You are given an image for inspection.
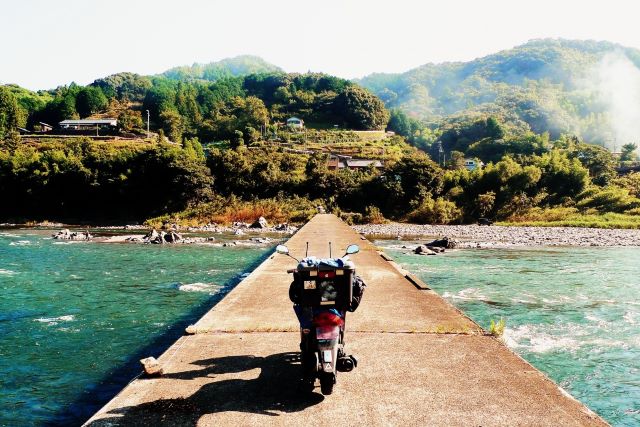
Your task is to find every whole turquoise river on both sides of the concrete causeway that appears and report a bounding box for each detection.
[0,229,640,426]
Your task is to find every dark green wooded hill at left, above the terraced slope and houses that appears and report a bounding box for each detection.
[0,70,389,144]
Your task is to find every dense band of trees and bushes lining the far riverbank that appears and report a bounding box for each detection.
[0,130,640,224]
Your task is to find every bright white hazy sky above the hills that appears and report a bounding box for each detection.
[0,0,640,89]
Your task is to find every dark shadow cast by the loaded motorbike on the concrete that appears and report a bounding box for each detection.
[89,353,324,427]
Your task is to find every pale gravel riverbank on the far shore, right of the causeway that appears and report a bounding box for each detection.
[353,223,640,248]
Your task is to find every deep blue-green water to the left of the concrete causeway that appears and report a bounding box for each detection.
[0,230,270,426]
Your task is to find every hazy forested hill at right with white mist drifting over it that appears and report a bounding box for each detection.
[358,39,640,148]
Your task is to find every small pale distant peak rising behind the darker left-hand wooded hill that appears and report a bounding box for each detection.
[161,55,284,81]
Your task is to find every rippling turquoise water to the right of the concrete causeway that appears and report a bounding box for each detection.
[376,241,640,426]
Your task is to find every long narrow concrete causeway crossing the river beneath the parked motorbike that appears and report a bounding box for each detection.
[85,214,607,427]
